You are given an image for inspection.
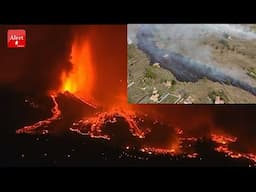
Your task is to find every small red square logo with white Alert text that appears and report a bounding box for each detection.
[7,29,26,48]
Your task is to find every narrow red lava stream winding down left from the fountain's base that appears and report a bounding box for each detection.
[16,95,61,134]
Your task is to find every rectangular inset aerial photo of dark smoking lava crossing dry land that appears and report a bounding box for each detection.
[127,24,256,104]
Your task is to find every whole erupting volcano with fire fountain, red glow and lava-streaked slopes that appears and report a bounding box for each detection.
[1,25,256,165]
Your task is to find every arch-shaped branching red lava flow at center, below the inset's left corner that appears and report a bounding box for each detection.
[70,109,145,140]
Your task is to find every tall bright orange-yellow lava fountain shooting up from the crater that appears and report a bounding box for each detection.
[61,39,94,101]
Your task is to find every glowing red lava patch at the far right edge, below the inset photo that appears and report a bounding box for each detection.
[212,134,256,162]
